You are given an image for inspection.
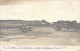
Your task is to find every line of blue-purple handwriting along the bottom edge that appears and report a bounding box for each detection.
[3,46,67,50]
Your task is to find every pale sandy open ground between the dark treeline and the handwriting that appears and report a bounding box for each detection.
[0,27,80,46]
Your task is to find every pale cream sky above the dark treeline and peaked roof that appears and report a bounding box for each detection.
[0,0,80,22]
